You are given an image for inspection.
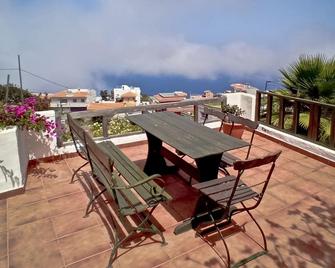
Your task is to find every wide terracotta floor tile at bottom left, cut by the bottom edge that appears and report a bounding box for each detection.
[9,241,63,268]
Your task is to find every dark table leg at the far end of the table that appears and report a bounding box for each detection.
[144,132,177,175]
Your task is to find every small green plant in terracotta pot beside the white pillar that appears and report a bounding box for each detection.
[221,104,244,139]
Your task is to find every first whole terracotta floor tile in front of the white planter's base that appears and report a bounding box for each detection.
[7,187,46,209]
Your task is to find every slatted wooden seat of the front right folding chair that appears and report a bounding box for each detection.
[193,176,259,207]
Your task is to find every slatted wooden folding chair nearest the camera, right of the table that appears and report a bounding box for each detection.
[192,151,281,265]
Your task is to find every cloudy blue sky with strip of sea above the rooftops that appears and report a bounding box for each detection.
[0,0,335,93]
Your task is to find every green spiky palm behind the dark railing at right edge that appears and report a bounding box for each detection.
[279,55,335,100]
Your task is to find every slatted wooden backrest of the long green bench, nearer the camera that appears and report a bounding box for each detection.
[84,132,114,186]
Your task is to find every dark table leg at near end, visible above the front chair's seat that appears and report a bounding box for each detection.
[195,153,222,182]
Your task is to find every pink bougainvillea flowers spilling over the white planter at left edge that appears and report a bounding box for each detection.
[0,97,56,137]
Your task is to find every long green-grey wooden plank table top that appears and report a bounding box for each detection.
[127,112,249,159]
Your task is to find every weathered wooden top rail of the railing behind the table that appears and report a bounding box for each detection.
[71,96,227,119]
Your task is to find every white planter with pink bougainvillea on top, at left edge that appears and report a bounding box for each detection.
[0,97,56,194]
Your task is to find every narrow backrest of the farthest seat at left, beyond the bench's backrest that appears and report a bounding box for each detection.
[67,113,87,160]
